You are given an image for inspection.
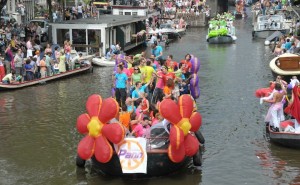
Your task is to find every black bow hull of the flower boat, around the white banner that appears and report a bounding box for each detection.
[92,152,192,179]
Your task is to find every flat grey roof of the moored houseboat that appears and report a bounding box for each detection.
[51,14,147,26]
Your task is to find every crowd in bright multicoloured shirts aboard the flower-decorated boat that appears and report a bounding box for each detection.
[112,43,196,137]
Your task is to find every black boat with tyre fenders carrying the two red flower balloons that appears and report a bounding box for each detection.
[76,121,204,179]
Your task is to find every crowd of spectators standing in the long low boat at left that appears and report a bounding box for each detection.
[0,40,83,84]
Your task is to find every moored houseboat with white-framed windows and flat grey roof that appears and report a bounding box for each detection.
[51,6,147,56]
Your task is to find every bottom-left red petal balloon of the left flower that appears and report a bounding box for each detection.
[77,135,95,160]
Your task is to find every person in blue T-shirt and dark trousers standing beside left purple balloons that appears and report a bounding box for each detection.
[113,65,128,107]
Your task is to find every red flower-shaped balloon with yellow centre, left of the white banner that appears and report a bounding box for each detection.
[77,94,125,163]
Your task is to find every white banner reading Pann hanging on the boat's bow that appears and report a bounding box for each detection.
[114,137,147,173]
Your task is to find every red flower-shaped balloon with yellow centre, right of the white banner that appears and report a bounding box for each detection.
[159,95,202,162]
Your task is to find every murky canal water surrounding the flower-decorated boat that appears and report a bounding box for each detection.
[0,8,300,185]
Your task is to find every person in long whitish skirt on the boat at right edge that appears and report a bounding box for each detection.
[264,83,286,132]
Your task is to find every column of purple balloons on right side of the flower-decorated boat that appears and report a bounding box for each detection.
[190,55,200,100]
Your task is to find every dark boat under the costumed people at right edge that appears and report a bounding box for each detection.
[266,120,300,149]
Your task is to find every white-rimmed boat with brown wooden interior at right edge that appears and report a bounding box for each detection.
[269,53,300,80]
